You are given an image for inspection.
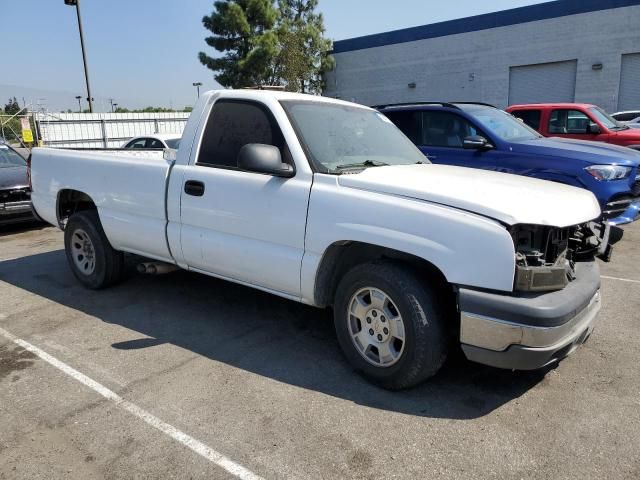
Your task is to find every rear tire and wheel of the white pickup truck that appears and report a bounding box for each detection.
[64,211,124,290]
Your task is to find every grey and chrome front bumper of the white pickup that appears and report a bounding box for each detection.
[458,262,601,370]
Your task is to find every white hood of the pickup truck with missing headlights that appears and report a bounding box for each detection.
[338,164,600,227]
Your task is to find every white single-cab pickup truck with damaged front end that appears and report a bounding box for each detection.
[31,90,608,389]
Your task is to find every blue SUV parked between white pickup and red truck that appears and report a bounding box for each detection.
[379,103,640,225]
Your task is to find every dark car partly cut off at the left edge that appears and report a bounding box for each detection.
[0,143,34,225]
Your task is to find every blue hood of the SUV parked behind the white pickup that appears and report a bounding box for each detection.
[511,138,640,167]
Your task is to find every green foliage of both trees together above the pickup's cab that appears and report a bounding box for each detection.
[199,0,333,93]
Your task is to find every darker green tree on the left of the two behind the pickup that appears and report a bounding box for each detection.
[198,0,278,88]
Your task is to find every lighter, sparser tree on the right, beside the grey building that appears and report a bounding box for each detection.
[272,0,334,94]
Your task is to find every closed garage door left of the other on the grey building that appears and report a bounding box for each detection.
[509,60,578,105]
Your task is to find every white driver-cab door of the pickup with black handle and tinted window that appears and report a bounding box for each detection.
[180,99,312,297]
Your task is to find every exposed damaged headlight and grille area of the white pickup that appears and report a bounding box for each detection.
[510,222,612,292]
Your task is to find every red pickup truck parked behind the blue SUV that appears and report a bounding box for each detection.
[507,103,640,150]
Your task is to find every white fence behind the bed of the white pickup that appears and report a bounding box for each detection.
[34,112,189,148]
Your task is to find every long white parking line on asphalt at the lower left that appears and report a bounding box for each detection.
[0,328,262,480]
